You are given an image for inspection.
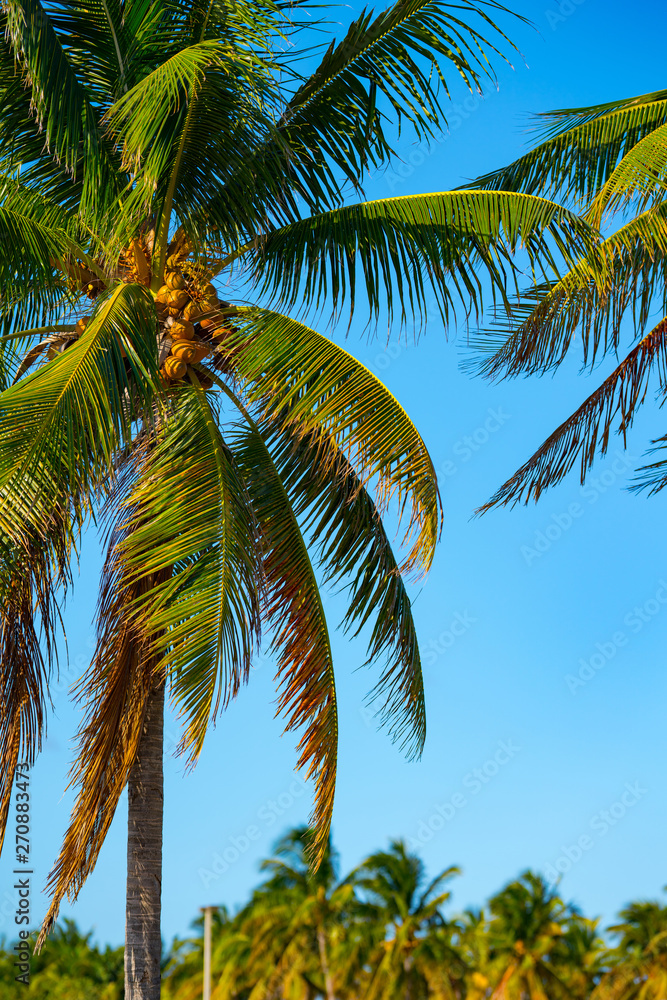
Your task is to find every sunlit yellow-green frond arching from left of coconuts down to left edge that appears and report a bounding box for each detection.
[0,285,161,537]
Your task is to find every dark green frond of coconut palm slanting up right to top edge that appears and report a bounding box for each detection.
[213,0,514,227]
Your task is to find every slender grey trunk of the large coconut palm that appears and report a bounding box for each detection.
[125,680,164,1000]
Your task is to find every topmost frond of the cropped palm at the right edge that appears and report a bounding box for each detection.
[475,90,667,205]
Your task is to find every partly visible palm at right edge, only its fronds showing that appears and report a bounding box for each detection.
[464,91,667,510]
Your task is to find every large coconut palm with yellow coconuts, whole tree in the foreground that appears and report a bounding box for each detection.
[0,0,589,1000]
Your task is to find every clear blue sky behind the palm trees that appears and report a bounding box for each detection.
[0,0,667,943]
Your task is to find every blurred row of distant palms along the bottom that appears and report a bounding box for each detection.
[0,829,667,1000]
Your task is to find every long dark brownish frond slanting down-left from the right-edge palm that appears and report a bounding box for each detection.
[478,318,667,513]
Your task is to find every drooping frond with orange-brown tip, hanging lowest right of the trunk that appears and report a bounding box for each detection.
[234,425,338,862]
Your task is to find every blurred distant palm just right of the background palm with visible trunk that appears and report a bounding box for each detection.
[351,840,464,1000]
